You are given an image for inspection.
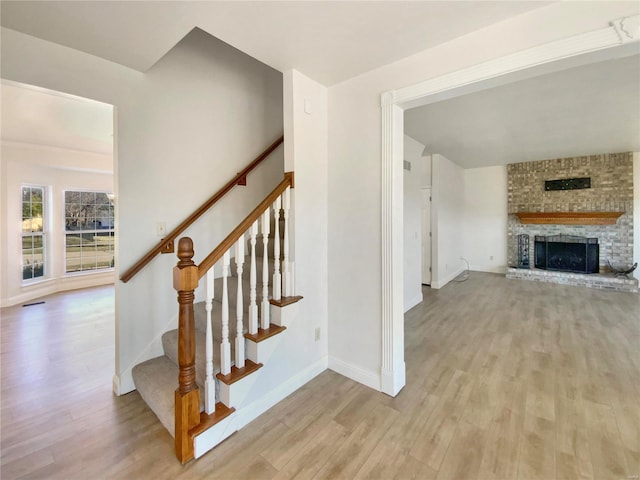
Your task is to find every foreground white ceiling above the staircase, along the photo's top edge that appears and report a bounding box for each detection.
[0,0,552,86]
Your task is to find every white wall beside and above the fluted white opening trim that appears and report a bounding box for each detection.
[329,2,636,384]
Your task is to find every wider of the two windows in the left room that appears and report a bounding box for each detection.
[64,190,115,273]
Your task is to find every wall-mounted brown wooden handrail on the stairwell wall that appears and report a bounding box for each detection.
[120,136,284,283]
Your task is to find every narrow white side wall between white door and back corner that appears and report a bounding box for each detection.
[431,154,465,289]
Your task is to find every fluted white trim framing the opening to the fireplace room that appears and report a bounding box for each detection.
[380,15,640,396]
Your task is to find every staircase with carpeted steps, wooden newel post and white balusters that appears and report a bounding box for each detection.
[132,172,302,463]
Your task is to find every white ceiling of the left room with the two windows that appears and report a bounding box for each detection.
[0,81,113,155]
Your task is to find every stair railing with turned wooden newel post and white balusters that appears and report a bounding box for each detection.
[173,172,294,463]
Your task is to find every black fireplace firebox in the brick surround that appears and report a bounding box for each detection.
[534,235,600,273]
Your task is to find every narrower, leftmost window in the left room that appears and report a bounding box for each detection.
[22,186,45,282]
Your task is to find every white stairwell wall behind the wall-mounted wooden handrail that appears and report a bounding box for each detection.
[2,29,283,393]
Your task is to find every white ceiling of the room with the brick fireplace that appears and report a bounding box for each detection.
[405,55,640,168]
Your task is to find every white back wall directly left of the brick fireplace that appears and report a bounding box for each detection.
[463,166,507,273]
